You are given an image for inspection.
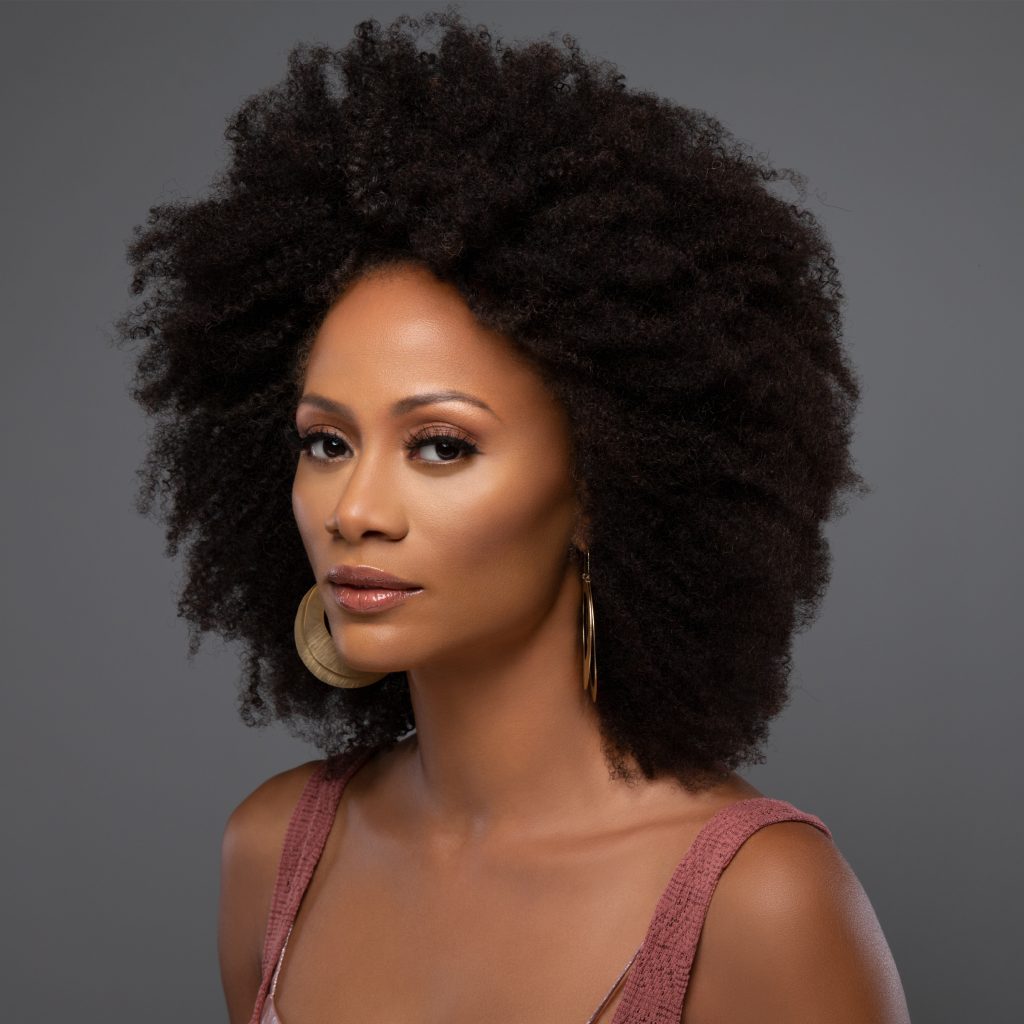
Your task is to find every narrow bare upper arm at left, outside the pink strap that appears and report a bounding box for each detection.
[217,761,319,1024]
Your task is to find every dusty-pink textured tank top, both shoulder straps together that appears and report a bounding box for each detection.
[249,748,833,1024]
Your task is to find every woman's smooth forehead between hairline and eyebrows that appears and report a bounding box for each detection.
[305,267,553,416]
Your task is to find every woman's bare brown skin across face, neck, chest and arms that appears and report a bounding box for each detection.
[219,267,908,1024]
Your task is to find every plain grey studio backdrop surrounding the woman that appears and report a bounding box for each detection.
[0,2,1024,1024]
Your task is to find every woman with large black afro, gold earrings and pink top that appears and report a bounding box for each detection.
[114,8,908,1024]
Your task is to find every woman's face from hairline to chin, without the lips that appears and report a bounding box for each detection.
[292,266,584,672]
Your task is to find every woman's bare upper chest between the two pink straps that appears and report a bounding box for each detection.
[275,823,700,1024]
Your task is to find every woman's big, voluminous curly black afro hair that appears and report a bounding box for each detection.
[114,4,870,791]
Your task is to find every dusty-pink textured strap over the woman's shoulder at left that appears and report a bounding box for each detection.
[249,748,377,1024]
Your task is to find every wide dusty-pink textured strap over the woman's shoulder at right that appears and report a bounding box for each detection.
[611,797,833,1024]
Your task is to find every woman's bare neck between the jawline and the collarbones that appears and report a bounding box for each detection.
[395,567,649,846]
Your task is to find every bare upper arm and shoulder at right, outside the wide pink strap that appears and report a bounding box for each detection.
[683,821,910,1024]
